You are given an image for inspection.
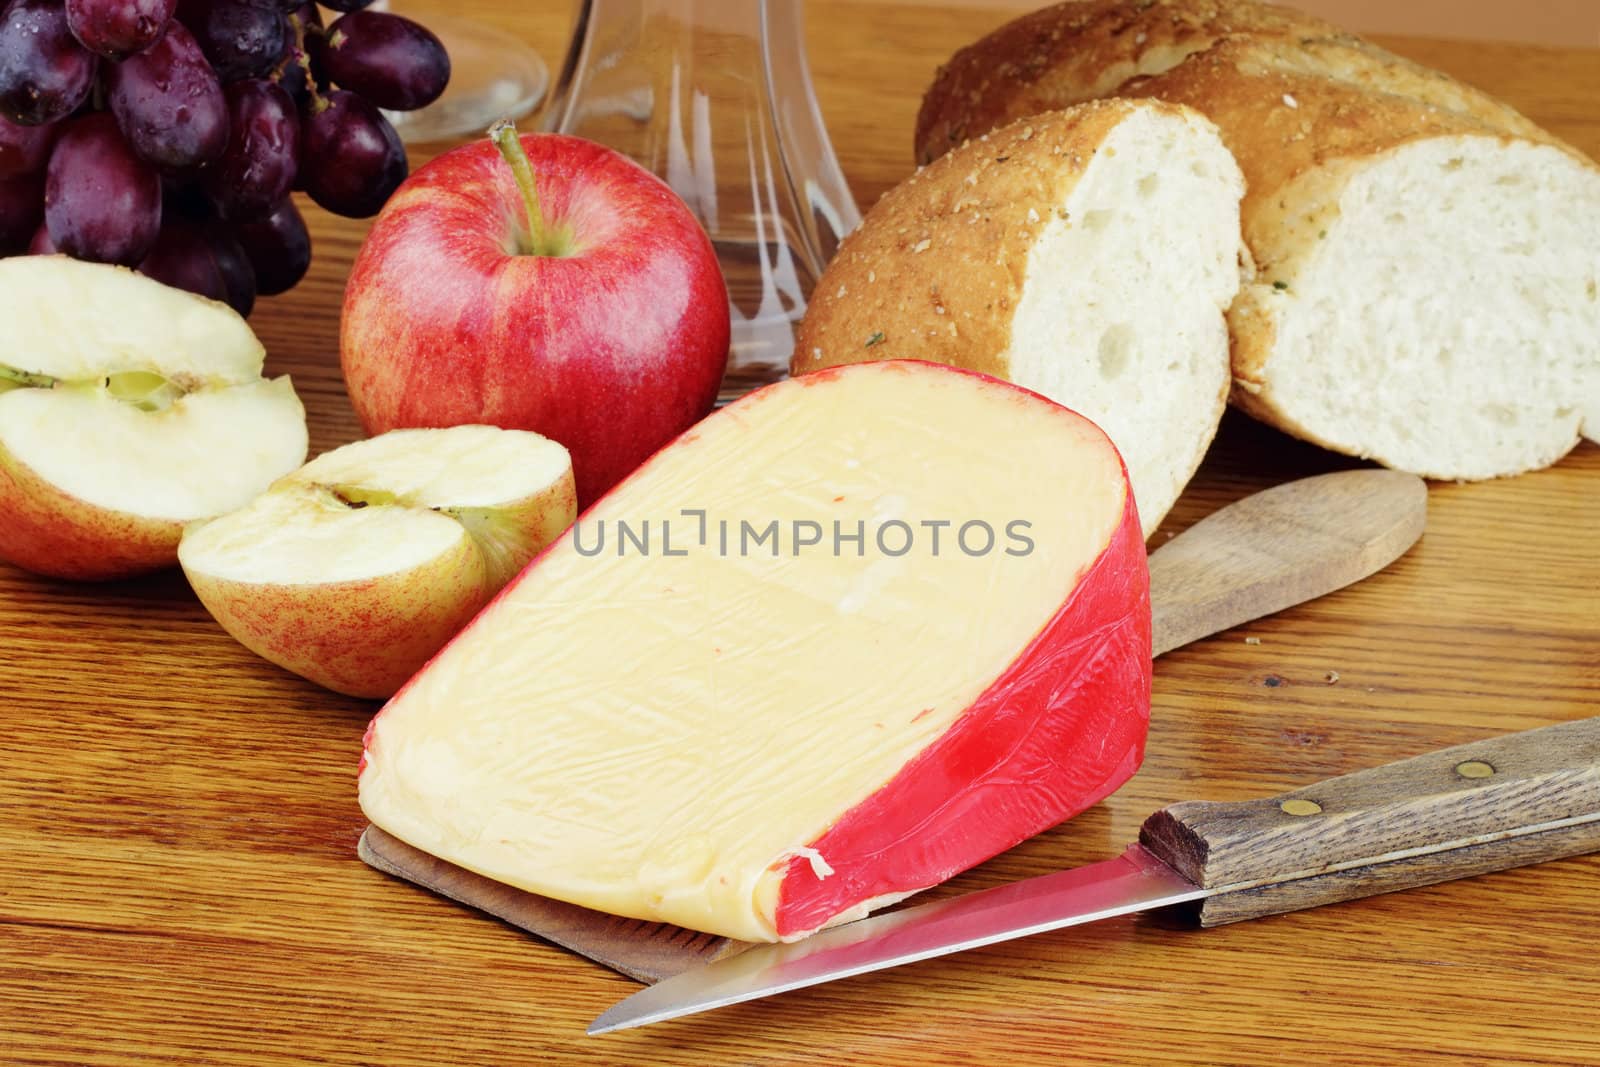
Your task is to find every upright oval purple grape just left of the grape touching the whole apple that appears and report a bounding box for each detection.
[202,78,299,222]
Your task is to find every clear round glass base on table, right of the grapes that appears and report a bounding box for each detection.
[371,0,550,144]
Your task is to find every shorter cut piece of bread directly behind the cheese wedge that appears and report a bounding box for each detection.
[790,101,1243,534]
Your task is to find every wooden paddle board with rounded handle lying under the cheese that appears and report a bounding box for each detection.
[357,470,1427,984]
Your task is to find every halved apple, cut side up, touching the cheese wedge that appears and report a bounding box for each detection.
[178,426,578,697]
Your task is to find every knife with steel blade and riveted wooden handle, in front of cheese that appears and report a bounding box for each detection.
[589,718,1600,1035]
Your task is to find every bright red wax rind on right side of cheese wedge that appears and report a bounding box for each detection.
[774,493,1150,937]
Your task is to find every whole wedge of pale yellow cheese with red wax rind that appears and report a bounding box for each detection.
[360,362,1150,941]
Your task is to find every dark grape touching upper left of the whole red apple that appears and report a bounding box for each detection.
[301,90,406,219]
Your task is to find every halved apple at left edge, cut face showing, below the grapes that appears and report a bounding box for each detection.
[0,256,306,579]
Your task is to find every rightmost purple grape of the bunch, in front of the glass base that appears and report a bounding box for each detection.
[326,11,450,110]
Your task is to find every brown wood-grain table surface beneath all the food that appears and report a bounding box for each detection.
[0,0,1600,1065]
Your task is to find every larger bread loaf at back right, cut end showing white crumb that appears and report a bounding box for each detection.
[917,0,1600,480]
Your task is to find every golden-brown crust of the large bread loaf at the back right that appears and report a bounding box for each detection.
[917,0,1595,474]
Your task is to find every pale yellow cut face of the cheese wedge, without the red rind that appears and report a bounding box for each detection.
[360,363,1126,939]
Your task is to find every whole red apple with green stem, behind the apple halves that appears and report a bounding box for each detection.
[339,126,728,506]
